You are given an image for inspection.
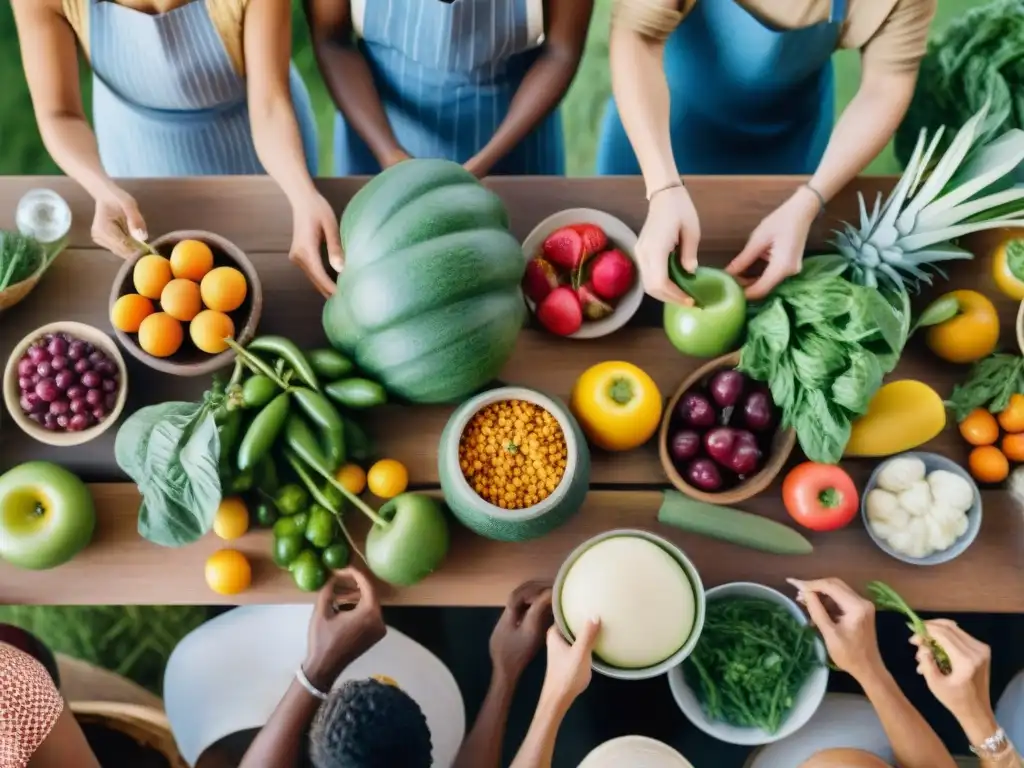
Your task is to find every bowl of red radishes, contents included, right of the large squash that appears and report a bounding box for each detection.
[522,208,643,339]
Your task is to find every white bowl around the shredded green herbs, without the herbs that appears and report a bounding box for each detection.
[669,582,828,746]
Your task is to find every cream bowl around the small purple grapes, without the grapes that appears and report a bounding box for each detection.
[3,321,128,447]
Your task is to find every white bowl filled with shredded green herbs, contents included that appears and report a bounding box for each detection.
[669,582,828,746]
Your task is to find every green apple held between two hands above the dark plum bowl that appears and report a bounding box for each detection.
[665,262,746,357]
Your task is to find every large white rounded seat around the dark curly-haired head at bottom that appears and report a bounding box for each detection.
[164,604,466,768]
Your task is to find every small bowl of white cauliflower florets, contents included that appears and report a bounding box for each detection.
[860,452,981,565]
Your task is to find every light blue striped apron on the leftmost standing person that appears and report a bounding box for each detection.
[88,0,316,177]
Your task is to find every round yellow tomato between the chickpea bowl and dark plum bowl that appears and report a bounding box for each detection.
[569,360,662,451]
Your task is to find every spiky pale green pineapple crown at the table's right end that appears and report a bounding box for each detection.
[835,102,1024,293]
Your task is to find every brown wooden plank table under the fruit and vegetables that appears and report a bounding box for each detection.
[0,177,1024,612]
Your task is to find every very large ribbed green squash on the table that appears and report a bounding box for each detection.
[324,160,526,402]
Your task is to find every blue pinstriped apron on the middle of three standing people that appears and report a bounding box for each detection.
[334,0,565,176]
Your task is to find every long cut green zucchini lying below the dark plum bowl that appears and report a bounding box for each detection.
[657,490,814,555]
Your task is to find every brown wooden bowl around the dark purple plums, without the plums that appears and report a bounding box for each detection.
[657,352,797,505]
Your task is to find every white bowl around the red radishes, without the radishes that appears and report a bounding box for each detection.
[522,208,643,339]
